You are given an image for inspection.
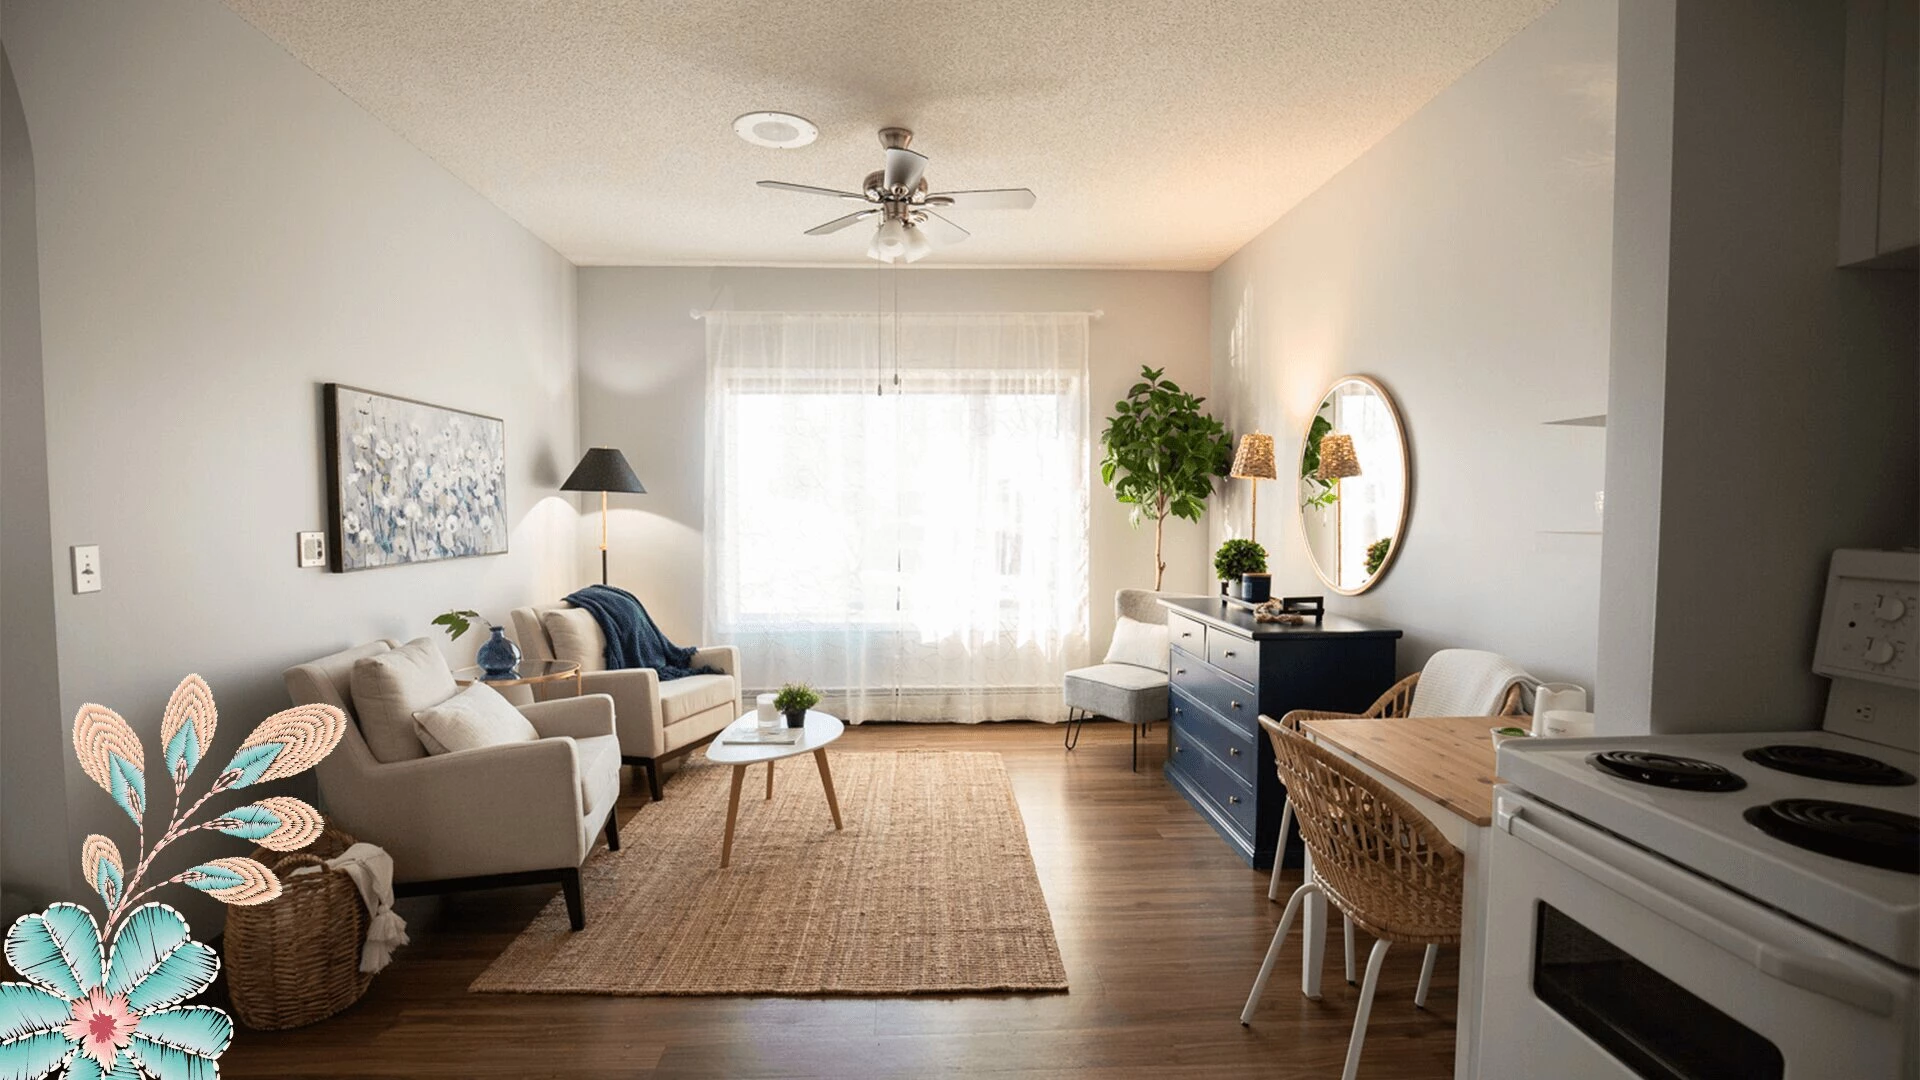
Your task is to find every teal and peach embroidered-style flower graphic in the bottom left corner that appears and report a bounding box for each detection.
[0,675,346,1080]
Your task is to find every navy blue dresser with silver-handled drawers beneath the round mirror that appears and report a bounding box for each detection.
[1160,596,1400,869]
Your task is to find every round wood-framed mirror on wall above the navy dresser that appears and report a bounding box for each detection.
[1300,375,1413,596]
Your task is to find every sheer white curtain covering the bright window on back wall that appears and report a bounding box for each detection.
[707,311,1089,723]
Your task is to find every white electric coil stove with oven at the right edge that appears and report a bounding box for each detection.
[1478,552,1920,1080]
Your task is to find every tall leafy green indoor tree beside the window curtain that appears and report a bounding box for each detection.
[1100,367,1233,590]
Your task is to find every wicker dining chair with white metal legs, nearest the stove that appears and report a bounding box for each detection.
[1240,717,1467,1080]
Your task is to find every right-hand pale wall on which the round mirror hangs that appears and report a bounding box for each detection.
[1212,0,1615,686]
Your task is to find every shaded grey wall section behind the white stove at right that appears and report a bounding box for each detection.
[1599,0,1920,734]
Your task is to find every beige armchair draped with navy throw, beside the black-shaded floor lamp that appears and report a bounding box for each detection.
[513,603,739,801]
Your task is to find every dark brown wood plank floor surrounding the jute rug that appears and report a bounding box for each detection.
[221,723,1457,1080]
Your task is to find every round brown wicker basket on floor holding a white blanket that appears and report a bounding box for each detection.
[225,828,372,1030]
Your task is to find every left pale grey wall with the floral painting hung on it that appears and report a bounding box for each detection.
[0,0,578,932]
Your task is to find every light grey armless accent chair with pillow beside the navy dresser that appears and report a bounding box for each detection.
[1062,588,1167,773]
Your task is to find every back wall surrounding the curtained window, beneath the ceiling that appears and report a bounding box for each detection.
[580,267,1212,653]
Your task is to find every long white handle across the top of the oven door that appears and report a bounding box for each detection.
[1498,805,1899,1017]
